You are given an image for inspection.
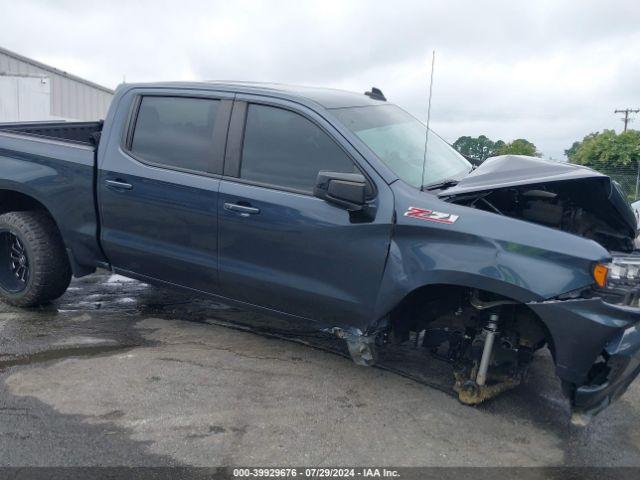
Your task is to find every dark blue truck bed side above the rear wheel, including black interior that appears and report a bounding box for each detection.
[0,122,103,272]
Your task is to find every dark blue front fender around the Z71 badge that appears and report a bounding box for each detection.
[376,182,609,324]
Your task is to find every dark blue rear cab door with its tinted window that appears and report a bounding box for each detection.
[98,90,233,292]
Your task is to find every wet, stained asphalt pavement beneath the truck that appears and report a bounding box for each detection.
[0,272,640,466]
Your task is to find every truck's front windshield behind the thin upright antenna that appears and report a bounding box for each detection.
[332,105,472,188]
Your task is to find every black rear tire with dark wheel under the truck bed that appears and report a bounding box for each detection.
[0,210,71,307]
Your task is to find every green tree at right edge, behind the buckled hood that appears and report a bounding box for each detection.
[565,130,640,173]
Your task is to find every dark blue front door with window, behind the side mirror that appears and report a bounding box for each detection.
[218,95,393,325]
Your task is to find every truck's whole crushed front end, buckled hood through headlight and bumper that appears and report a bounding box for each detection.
[432,156,640,420]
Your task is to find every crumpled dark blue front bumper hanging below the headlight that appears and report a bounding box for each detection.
[530,297,640,416]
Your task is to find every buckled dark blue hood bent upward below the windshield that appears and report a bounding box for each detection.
[438,155,637,251]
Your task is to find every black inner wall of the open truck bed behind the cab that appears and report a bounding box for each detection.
[0,120,104,146]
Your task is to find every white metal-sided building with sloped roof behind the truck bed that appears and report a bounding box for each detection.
[0,47,113,122]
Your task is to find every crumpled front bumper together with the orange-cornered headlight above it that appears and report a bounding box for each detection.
[530,254,640,424]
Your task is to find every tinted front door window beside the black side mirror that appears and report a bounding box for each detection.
[240,105,357,193]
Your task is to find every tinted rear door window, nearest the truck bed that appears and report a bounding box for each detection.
[131,97,220,172]
